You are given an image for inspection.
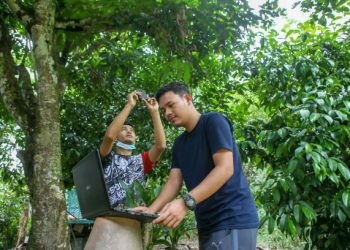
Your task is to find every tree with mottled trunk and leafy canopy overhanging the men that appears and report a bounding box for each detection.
[0,0,282,249]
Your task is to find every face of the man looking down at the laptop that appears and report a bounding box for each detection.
[159,91,191,127]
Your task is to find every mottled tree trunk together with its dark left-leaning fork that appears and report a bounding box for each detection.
[0,0,70,250]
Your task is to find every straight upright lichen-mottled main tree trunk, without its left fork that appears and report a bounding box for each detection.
[25,0,70,249]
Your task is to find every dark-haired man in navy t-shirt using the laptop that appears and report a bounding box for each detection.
[133,82,259,250]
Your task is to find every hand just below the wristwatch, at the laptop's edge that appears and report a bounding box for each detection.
[153,199,188,228]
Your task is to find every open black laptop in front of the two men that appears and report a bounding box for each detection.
[72,149,159,222]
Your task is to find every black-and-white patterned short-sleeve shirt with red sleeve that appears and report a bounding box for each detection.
[103,151,154,207]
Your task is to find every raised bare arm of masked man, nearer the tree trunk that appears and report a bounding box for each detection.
[100,91,137,158]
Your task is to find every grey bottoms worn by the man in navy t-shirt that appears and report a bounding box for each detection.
[198,228,258,250]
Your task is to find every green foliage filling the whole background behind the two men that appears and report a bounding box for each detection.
[0,0,350,249]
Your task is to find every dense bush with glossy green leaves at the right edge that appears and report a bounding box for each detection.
[245,18,350,249]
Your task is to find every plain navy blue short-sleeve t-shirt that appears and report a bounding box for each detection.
[172,112,259,233]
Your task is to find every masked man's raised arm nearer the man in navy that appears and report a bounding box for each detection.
[144,98,166,163]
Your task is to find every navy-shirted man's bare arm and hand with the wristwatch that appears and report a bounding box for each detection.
[153,149,233,228]
